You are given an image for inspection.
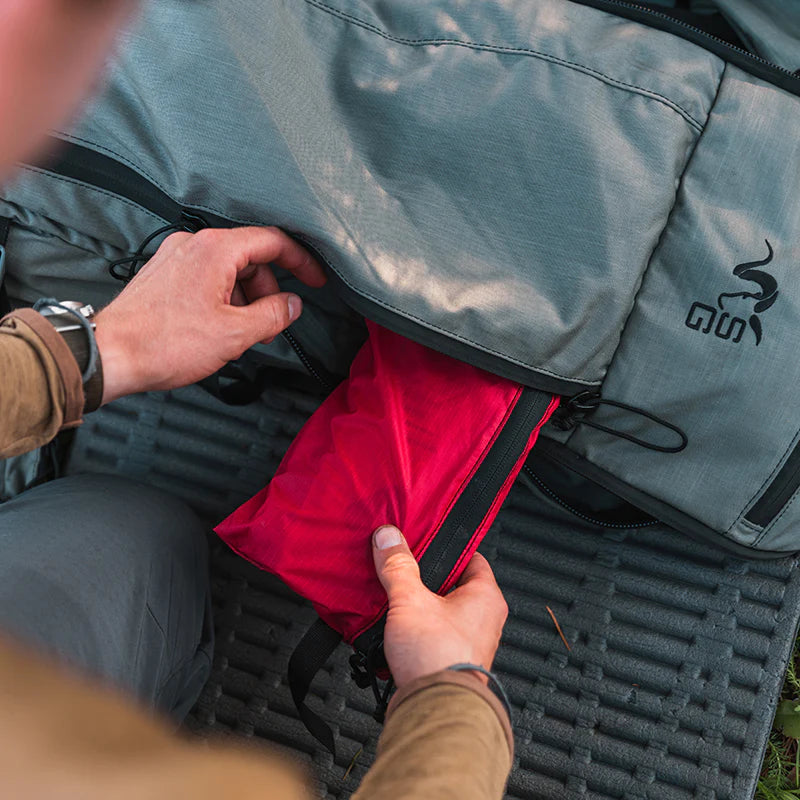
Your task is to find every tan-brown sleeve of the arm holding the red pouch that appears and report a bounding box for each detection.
[353,672,513,800]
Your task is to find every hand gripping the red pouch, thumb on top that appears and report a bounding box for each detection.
[373,525,508,687]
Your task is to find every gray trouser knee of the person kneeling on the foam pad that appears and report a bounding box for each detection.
[0,475,213,719]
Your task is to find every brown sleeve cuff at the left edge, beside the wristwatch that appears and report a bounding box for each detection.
[0,311,83,458]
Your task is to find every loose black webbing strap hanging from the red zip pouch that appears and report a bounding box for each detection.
[288,619,342,756]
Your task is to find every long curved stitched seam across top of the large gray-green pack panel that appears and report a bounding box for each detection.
[305,0,703,131]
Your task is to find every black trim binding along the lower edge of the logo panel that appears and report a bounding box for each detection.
[536,432,795,561]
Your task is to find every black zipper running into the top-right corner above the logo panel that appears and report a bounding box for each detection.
[571,0,800,96]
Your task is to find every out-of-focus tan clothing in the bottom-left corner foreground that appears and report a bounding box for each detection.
[0,635,311,800]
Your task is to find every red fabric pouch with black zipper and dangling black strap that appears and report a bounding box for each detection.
[216,323,558,750]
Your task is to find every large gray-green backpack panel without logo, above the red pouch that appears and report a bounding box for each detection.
[54,0,723,384]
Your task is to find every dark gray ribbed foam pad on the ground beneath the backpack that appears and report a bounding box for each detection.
[69,388,800,800]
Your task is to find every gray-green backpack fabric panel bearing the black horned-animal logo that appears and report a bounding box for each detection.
[569,66,800,549]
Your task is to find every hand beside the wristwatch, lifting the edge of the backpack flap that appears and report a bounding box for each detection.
[96,228,325,403]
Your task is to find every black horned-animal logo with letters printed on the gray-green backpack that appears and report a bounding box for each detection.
[685,239,778,346]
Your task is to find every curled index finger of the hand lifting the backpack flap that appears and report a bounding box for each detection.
[221,228,327,287]
